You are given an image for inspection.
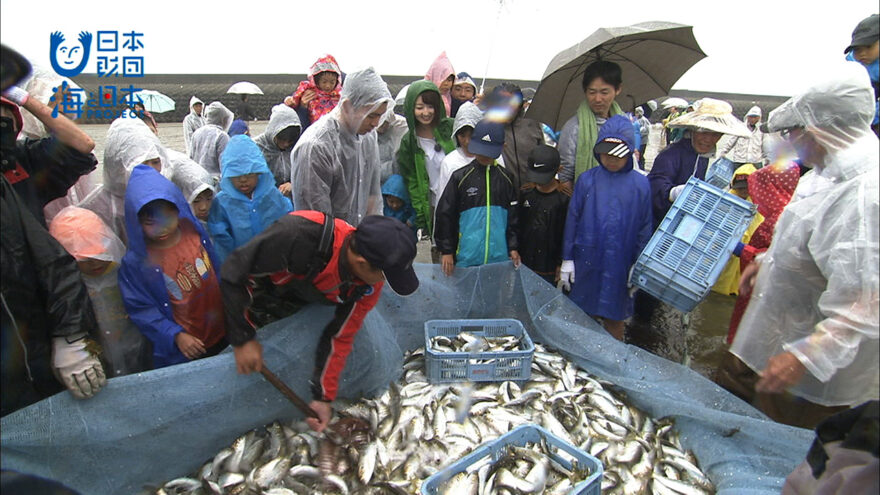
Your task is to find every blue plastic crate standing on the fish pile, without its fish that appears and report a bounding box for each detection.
[425,319,535,383]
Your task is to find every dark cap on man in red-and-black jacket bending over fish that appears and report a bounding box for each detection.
[354,215,419,296]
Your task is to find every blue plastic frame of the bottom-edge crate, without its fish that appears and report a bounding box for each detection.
[421,423,604,495]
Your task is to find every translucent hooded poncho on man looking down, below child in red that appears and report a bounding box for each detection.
[290,68,393,226]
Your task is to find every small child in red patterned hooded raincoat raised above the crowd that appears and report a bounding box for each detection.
[284,55,342,122]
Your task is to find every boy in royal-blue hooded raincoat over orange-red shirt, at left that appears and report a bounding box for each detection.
[119,165,227,368]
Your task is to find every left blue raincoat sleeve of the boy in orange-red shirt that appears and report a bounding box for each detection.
[119,258,186,367]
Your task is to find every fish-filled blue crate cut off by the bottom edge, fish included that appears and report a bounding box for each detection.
[422,423,602,495]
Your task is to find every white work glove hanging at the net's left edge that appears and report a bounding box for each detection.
[52,337,107,399]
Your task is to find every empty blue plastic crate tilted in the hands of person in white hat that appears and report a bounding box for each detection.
[630,177,755,313]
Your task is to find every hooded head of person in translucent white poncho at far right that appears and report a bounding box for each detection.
[768,62,877,168]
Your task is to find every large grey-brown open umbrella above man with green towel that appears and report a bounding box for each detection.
[527,22,706,129]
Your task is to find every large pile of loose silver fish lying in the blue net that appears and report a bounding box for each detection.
[152,344,715,495]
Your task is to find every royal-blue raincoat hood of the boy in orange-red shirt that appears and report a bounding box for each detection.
[125,165,207,258]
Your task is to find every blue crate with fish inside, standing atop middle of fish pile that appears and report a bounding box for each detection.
[425,318,535,383]
